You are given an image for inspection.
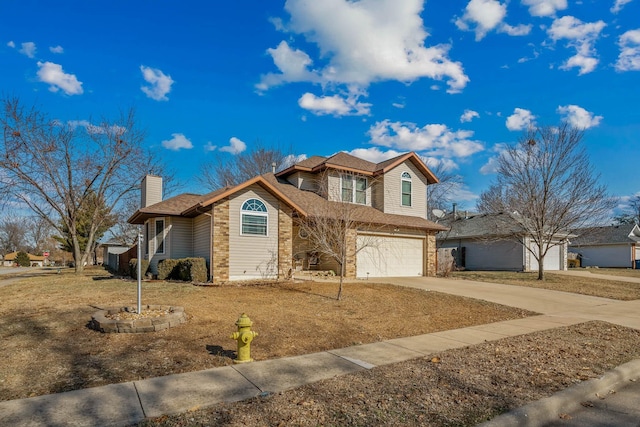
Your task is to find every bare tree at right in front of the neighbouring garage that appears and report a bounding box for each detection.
[477,123,613,280]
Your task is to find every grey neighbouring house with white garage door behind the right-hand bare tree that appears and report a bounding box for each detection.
[436,213,569,271]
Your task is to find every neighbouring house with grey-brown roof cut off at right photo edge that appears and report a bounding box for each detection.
[569,224,640,268]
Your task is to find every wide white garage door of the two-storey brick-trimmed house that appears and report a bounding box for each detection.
[356,235,424,278]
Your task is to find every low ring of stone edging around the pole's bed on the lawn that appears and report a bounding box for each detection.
[89,305,187,334]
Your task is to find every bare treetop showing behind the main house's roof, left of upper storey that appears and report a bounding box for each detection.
[197,142,294,190]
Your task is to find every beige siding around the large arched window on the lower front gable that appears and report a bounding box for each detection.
[229,184,279,280]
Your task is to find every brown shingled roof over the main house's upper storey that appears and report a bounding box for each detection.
[276,151,438,184]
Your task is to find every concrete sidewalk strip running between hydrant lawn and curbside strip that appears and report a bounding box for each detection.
[0,315,583,426]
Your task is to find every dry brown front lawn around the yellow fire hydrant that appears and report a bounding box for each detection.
[0,270,531,400]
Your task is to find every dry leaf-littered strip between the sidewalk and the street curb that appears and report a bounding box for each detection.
[139,322,640,427]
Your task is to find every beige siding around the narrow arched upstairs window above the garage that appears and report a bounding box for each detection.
[378,161,427,218]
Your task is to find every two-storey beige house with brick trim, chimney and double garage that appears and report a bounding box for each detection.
[129,153,445,283]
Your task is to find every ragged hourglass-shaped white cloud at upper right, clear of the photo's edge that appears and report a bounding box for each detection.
[547,16,607,75]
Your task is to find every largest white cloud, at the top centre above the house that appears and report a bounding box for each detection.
[256,0,469,92]
